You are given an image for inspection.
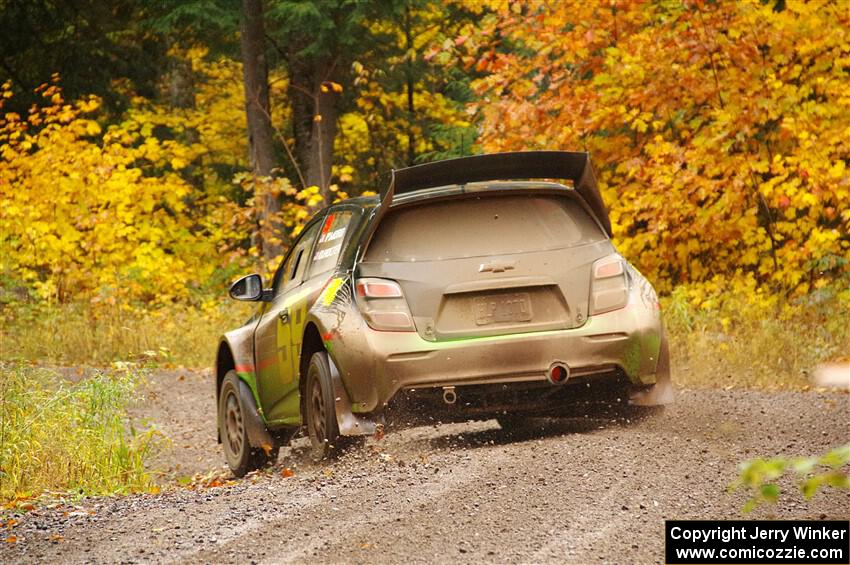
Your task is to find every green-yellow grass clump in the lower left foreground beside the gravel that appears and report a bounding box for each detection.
[0,363,157,508]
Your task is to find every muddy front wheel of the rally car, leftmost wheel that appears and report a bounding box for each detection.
[218,371,279,477]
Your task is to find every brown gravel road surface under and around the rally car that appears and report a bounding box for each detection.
[0,372,850,564]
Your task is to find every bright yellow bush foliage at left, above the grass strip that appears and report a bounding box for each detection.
[0,79,252,302]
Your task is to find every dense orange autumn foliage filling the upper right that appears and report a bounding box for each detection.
[464,0,850,292]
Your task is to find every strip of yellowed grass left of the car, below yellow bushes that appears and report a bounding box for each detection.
[0,301,252,368]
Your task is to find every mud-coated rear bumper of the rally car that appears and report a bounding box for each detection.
[333,292,669,412]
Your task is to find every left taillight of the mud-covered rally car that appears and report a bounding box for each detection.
[354,278,416,332]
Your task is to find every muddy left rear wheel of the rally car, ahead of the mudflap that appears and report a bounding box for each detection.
[304,351,362,462]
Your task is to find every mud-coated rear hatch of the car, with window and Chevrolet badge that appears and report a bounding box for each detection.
[357,188,614,341]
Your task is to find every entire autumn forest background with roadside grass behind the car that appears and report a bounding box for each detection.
[0,0,850,388]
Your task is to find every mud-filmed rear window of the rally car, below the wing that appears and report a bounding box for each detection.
[366,195,605,261]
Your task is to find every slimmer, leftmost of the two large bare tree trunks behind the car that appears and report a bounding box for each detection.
[241,0,283,259]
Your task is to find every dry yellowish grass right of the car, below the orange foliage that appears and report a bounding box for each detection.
[661,280,850,390]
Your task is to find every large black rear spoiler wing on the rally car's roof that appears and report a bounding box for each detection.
[381,151,612,237]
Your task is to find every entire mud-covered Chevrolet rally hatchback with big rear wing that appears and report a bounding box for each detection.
[215,151,671,475]
